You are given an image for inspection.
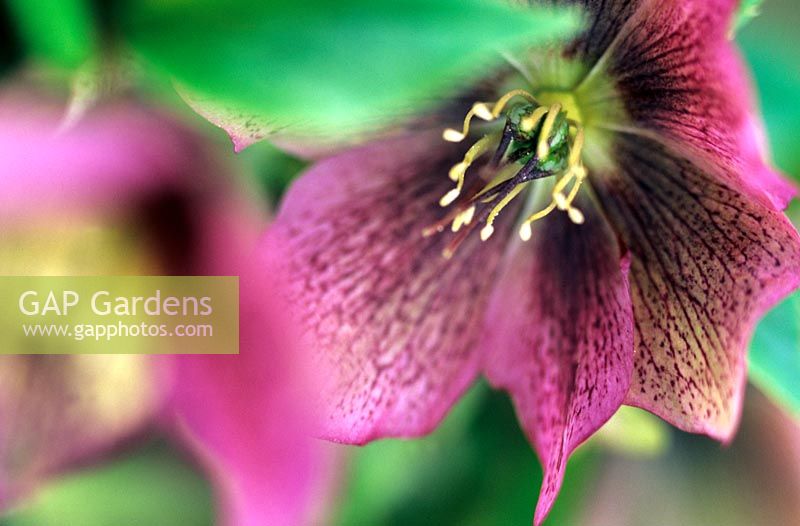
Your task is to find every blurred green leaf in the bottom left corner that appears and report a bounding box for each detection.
[0,442,214,526]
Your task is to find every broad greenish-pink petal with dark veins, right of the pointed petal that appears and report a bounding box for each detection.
[592,135,800,440]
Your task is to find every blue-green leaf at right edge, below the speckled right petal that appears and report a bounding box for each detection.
[750,292,800,416]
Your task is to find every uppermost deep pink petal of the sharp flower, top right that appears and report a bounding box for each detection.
[608,0,795,208]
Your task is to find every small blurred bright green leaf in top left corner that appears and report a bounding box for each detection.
[8,0,96,69]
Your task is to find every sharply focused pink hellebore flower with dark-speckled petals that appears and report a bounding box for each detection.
[264,0,800,524]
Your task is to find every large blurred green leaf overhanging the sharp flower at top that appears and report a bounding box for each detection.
[123,0,579,140]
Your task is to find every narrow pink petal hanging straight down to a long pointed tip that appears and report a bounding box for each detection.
[481,196,633,525]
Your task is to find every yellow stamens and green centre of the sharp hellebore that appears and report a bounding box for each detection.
[423,89,588,258]
